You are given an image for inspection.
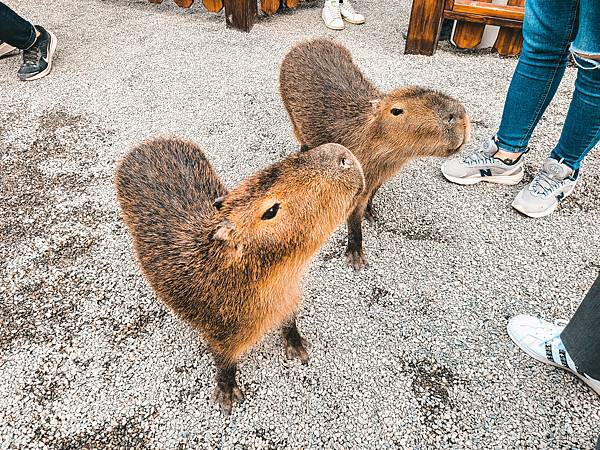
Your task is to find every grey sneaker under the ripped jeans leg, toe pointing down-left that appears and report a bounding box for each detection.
[512,158,578,217]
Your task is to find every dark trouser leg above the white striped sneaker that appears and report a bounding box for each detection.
[560,275,600,380]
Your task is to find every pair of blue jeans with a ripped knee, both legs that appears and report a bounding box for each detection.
[497,0,600,170]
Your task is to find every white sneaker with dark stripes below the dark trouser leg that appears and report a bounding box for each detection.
[506,315,600,395]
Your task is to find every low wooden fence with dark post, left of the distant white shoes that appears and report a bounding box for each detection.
[148,0,300,31]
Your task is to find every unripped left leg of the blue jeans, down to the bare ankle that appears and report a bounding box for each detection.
[497,0,579,158]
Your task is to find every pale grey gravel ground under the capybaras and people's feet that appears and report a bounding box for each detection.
[0,0,600,449]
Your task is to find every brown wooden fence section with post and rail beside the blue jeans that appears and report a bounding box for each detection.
[404,0,525,56]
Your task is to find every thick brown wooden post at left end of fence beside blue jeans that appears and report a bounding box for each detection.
[404,0,444,55]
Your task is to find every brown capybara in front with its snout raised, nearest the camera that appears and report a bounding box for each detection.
[115,138,364,412]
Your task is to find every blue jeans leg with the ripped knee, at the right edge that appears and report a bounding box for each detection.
[551,0,600,171]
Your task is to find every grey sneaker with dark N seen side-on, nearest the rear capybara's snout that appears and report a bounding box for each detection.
[442,139,525,184]
